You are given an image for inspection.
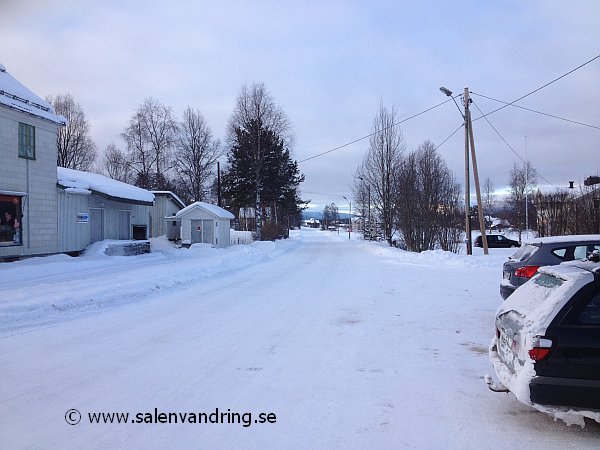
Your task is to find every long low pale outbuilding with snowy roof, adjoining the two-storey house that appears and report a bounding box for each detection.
[55,167,154,252]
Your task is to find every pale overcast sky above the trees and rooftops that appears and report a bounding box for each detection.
[0,0,600,211]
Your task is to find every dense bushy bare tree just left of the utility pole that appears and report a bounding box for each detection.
[397,141,460,252]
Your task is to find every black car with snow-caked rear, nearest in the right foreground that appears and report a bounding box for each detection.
[486,252,600,425]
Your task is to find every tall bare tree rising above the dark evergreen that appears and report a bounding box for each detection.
[227,83,293,240]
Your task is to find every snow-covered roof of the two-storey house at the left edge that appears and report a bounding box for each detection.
[0,64,67,125]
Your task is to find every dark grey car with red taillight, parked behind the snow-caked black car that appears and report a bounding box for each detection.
[500,234,600,300]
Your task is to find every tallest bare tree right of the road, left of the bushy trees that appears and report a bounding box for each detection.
[357,104,406,245]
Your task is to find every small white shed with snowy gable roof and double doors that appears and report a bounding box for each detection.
[175,202,234,247]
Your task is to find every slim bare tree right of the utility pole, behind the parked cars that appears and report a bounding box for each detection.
[507,161,537,241]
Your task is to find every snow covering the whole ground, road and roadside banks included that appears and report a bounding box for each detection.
[0,229,600,449]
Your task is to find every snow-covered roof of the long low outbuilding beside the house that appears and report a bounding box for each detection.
[56,167,154,205]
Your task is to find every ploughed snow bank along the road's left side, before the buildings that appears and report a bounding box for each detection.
[0,237,294,330]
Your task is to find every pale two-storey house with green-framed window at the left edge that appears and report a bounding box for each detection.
[0,64,67,261]
